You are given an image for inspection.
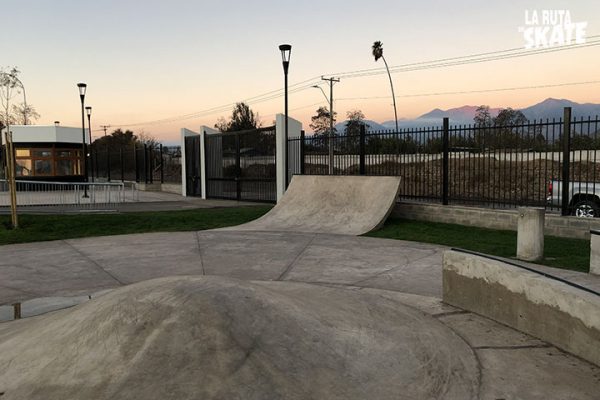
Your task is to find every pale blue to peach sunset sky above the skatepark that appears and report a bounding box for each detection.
[0,0,600,144]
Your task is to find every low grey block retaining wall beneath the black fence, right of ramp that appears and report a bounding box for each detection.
[392,202,600,239]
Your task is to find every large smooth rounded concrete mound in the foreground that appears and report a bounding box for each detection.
[0,277,480,400]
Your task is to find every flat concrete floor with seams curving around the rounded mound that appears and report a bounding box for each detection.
[0,231,600,399]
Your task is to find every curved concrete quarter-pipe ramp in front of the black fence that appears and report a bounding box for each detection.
[232,175,400,235]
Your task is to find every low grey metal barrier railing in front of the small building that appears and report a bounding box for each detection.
[0,180,138,209]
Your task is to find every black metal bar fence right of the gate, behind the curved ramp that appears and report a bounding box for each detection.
[288,105,600,214]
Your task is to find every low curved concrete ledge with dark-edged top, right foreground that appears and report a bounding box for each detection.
[443,250,600,365]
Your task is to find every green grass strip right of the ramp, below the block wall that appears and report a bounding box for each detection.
[367,218,590,272]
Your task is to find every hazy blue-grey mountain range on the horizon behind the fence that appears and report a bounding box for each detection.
[335,98,600,132]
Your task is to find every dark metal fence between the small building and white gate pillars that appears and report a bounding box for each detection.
[88,144,181,183]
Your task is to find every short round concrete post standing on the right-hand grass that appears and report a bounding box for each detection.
[517,207,546,261]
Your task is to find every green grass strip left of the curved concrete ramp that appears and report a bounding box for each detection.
[0,206,271,244]
